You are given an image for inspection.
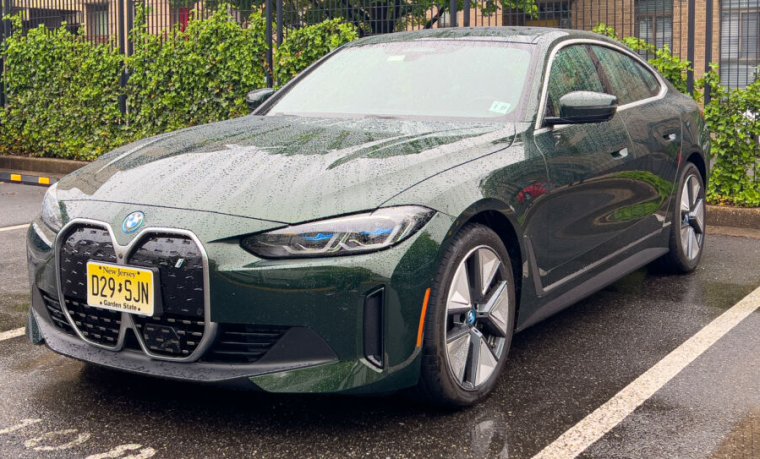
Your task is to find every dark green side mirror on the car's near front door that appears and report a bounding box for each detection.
[545,91,617,126]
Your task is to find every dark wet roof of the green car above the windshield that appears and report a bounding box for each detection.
[349,26,609,46]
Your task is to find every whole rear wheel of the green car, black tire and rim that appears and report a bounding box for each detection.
[656,163,707,274]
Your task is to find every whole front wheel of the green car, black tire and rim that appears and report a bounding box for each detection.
[417,224,516,407]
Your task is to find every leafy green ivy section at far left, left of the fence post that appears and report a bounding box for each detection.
[0,16,126,159]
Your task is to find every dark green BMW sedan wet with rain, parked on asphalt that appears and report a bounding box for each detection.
[27,28,709,405]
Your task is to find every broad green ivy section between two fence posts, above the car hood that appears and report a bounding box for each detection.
[127,8,267,137]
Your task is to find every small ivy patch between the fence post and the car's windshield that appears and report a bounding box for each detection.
[275,19,359,86]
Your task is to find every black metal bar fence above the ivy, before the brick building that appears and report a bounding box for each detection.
[0,0,760,102]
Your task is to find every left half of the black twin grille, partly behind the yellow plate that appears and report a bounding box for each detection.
[60,225,121,346]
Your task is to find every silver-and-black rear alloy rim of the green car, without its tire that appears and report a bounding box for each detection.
[681,175,705,261]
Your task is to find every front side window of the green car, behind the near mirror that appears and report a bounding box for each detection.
[546,45,604,116]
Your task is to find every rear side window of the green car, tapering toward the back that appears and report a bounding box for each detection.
[591,46,660,105]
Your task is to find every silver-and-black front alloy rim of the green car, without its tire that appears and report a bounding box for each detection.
[445,245,512,390]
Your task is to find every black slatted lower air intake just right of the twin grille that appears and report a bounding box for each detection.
[204,324,289,363]
